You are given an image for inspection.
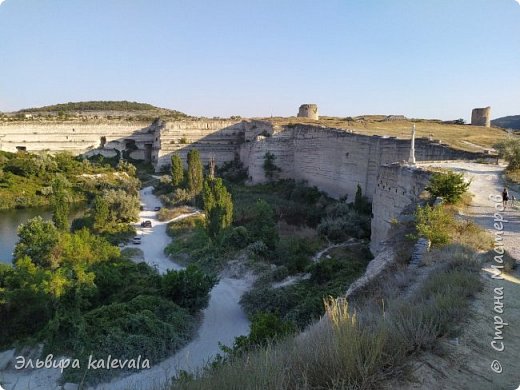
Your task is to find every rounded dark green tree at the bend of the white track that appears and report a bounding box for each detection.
[161,264,217,313]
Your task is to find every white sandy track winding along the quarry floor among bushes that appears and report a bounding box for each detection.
[0,187,253,390]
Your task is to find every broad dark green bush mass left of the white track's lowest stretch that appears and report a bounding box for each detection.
[56,295,194,383]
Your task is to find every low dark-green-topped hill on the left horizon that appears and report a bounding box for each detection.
[18,100,187,117]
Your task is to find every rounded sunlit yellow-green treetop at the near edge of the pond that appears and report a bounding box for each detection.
[14,216,59,267]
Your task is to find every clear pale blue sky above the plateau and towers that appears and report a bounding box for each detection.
[0,0,520,119]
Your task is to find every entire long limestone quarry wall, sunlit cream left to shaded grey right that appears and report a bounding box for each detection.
[0,119,485,253]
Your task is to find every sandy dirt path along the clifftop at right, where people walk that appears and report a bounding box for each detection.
[396,162,520,390]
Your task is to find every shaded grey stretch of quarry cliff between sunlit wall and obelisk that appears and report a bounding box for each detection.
[240,125,476,200]
